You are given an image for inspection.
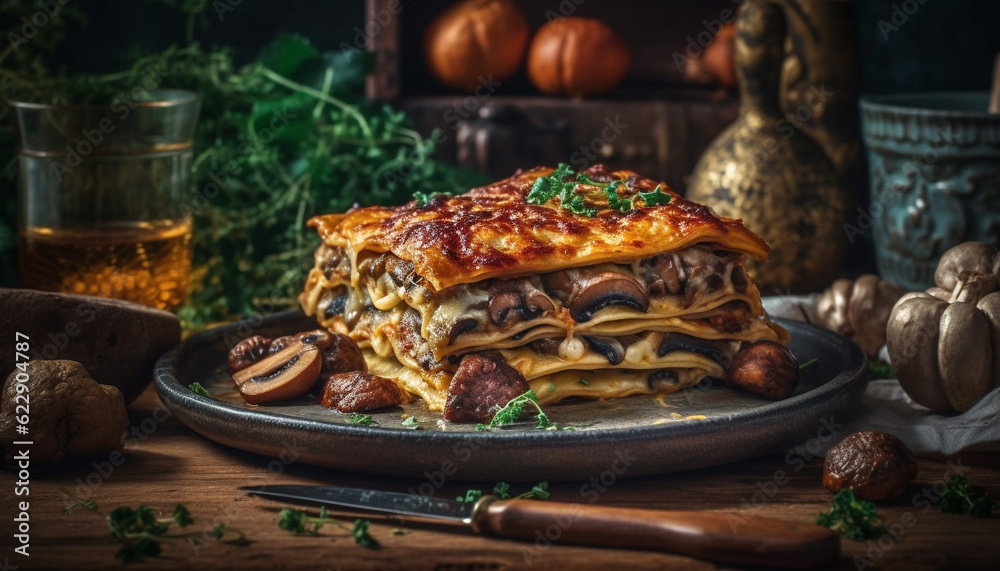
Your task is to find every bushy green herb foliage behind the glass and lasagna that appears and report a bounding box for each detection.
[0,0,486,328]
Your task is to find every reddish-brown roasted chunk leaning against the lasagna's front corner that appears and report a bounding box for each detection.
[444,353,531,422]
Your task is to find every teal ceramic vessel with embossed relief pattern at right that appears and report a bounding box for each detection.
[845,92,1000,290]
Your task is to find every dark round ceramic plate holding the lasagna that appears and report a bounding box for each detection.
[156,312,868,485]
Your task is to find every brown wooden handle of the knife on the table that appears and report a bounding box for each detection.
[472,496,840,567]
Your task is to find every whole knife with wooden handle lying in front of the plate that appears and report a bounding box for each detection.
[240,485,840,567]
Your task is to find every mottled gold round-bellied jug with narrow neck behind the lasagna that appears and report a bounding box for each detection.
[687,0,848,295]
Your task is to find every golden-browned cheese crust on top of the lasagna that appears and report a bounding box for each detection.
[309,167,768,291]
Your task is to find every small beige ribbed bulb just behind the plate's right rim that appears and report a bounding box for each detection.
[816,274,904,357]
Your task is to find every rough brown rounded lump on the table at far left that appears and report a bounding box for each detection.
[0,360,128,462]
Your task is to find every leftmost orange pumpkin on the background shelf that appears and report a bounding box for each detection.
[424,0,531,92]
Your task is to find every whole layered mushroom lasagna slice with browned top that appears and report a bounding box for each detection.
[299,165,788,420]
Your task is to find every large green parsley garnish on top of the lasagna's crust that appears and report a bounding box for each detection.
[527,163,672,217]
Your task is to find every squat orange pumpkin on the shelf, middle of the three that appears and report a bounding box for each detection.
[528,16,632,96]
